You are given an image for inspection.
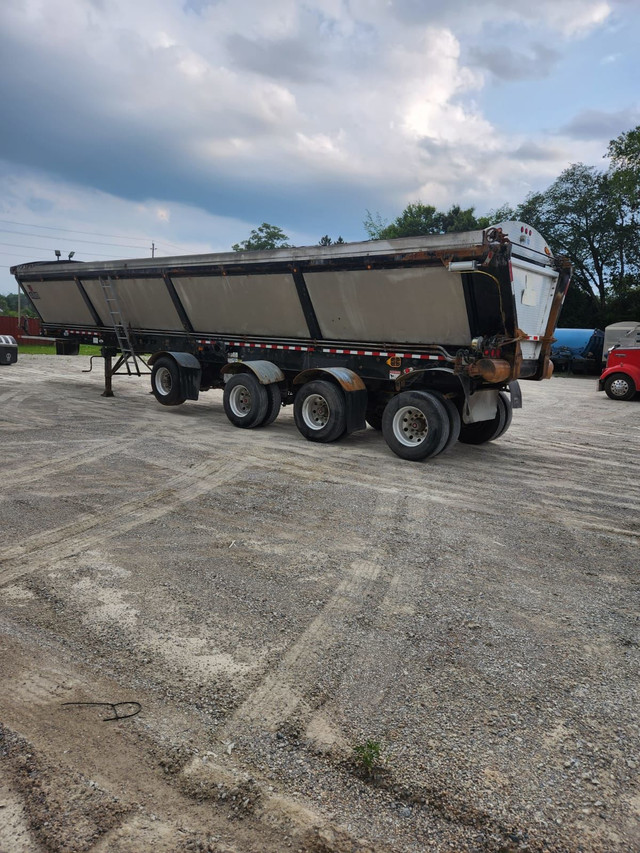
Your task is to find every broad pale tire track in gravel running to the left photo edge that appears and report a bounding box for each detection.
[0,461,249,587]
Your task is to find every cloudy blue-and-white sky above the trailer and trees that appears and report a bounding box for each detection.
[0,0,640,293]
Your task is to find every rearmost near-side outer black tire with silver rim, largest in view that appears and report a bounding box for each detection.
[382,391,450,462]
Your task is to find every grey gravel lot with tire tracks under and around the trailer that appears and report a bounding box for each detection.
[0,355,640,853]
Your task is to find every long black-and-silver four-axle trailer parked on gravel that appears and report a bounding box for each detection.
[11,222,571,460]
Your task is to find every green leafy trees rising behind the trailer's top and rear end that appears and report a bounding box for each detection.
[233,125,640,328]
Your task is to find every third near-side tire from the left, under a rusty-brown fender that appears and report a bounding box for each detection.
[293,379,347,443]
